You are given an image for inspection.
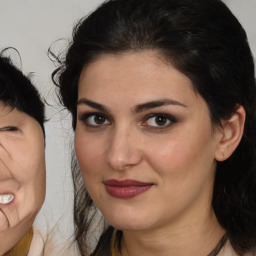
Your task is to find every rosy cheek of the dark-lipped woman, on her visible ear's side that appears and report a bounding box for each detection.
[145,127,214,178]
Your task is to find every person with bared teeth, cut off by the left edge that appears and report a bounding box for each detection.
[0,52,45,256]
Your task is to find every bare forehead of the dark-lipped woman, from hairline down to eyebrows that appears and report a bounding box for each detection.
[78,51,198,107]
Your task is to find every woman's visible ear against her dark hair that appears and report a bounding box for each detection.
[215,106,246,162]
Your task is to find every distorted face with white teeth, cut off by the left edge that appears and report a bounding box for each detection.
[0,104,45,254]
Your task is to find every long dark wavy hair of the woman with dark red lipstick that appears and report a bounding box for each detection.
[52,0,256,255]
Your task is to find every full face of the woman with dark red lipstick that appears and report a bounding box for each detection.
[75,51,220,230]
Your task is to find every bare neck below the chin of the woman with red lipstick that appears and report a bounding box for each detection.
[121,212,225,256]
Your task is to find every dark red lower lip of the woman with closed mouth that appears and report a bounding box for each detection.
[105,184,153,198]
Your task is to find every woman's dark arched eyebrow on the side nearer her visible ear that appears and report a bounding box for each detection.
[132,99,187,113]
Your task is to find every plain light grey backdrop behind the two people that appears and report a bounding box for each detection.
[0,0,256,249]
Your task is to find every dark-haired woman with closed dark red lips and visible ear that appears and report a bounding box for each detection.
[53,0,256,256]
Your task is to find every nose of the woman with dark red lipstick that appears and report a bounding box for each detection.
[107,125,143,171]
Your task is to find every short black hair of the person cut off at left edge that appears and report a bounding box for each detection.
[0,50,45,134]
